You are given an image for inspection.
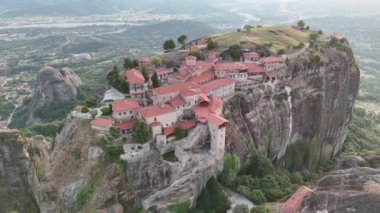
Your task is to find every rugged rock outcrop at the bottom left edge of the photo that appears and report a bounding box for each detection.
[0,130,48,212]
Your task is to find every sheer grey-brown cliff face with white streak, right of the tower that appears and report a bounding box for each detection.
[225,45,360,159]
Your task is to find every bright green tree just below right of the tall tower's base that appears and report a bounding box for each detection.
[220,153,240,186]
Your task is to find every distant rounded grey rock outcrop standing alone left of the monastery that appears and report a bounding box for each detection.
[27,66,82,123]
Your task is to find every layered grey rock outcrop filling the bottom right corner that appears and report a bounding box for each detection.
[302,167,380,213]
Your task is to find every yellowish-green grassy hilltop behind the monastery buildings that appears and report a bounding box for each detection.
[211,26,310,53]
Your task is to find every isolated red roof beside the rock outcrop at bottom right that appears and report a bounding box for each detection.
[281,186,313,213]
